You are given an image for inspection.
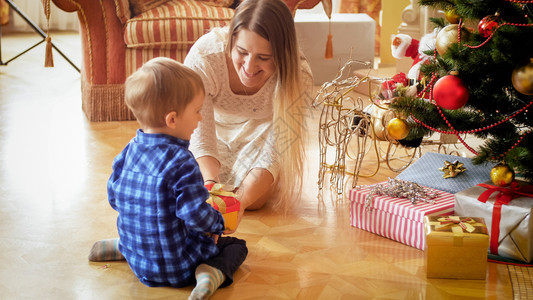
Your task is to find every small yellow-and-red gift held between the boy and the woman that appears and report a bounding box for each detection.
[206,183,241,230]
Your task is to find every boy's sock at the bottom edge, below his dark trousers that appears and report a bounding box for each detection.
[189,264,226,300]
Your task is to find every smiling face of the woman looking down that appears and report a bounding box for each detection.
[231,29,275,89]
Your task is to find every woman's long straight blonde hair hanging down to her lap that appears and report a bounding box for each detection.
[226,0,306,211]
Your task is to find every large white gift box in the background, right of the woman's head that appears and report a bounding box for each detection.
[294,10,376,85]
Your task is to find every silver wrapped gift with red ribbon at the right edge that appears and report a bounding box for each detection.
[455,182,533,263]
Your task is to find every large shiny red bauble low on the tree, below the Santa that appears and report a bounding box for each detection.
[433,75,469,109]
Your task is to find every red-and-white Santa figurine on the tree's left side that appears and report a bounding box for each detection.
[391,30,438,81]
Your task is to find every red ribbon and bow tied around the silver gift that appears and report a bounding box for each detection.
[477,181,533,255]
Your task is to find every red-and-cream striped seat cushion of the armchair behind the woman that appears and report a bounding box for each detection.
[124,0,233,50]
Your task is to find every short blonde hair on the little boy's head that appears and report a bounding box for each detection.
[124,57,205,127]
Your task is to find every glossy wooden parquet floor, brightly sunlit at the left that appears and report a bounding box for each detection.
[0,33,513,300]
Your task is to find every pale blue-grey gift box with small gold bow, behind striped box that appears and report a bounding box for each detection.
[396,152,494,194]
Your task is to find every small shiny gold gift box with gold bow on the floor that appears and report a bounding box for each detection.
[424,216,489,279]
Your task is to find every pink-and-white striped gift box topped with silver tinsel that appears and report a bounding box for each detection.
[349,183,455,250]
